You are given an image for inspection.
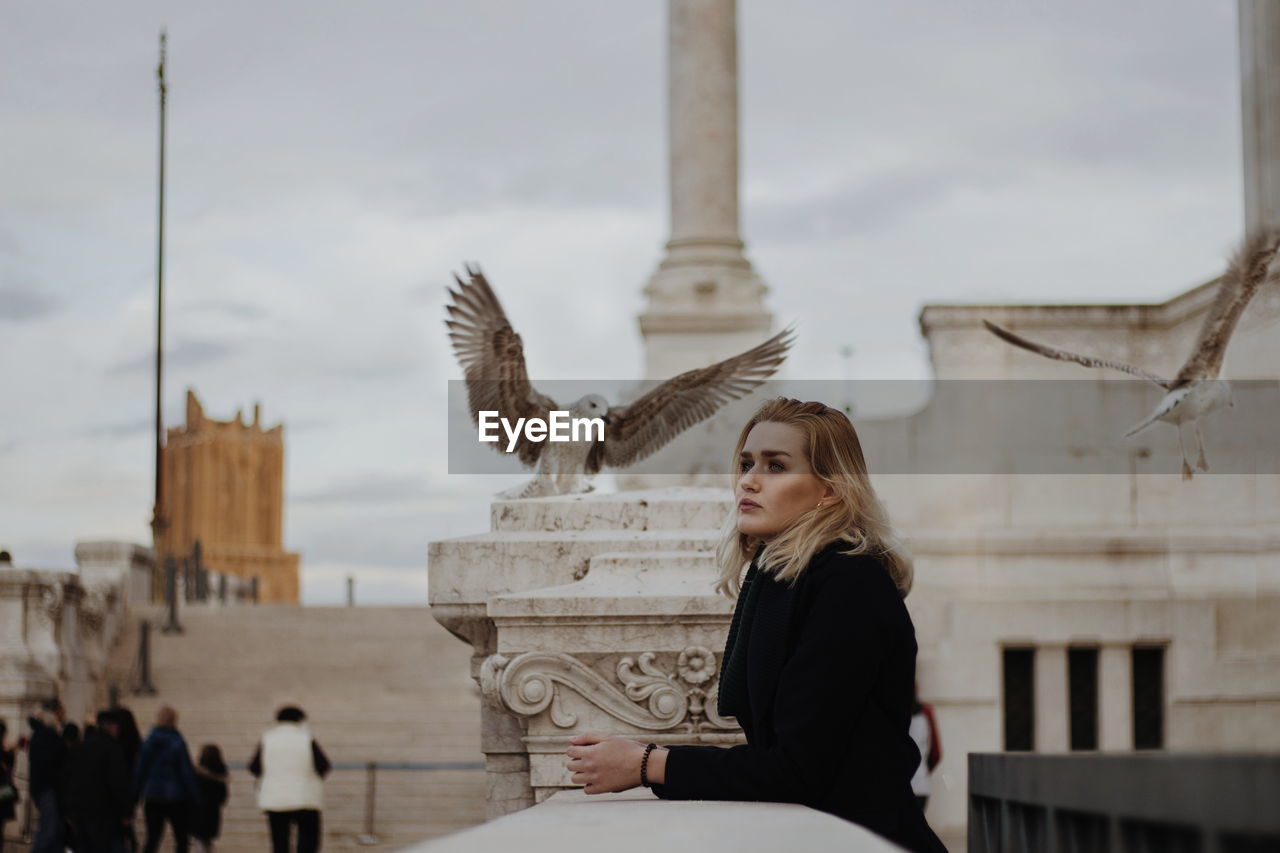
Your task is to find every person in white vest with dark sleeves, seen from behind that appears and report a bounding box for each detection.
[248,706,332,853]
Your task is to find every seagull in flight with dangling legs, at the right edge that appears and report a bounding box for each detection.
[983,229,1280,480]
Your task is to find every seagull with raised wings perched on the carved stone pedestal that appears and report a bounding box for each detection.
[444,266,794,498]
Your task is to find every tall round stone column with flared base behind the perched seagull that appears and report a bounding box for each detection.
[640,0,773,379]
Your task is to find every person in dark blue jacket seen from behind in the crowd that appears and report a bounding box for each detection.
[134,706,200,853]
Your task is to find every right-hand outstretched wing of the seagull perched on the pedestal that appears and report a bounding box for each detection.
[586,329,794,474]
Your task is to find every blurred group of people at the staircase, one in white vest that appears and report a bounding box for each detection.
[0,698,330,853]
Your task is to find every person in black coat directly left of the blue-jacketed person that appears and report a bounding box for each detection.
[67,711,133,853]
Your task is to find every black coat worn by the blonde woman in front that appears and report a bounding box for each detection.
[654,542,946,853]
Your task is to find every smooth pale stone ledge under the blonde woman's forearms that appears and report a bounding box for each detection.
[410,789,901,853]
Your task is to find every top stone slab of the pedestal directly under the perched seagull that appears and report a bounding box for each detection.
[489,488,732,532]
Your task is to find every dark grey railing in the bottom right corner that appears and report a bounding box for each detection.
[969,753,1280,853]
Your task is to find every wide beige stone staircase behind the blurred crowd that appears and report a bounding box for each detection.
[111,606,485,853]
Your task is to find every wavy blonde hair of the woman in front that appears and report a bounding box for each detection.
[716,397,914,598]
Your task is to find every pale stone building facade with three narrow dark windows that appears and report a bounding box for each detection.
[896,268,1280,827]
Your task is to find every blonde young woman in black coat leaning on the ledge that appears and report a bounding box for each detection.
[567,397,946,853]
